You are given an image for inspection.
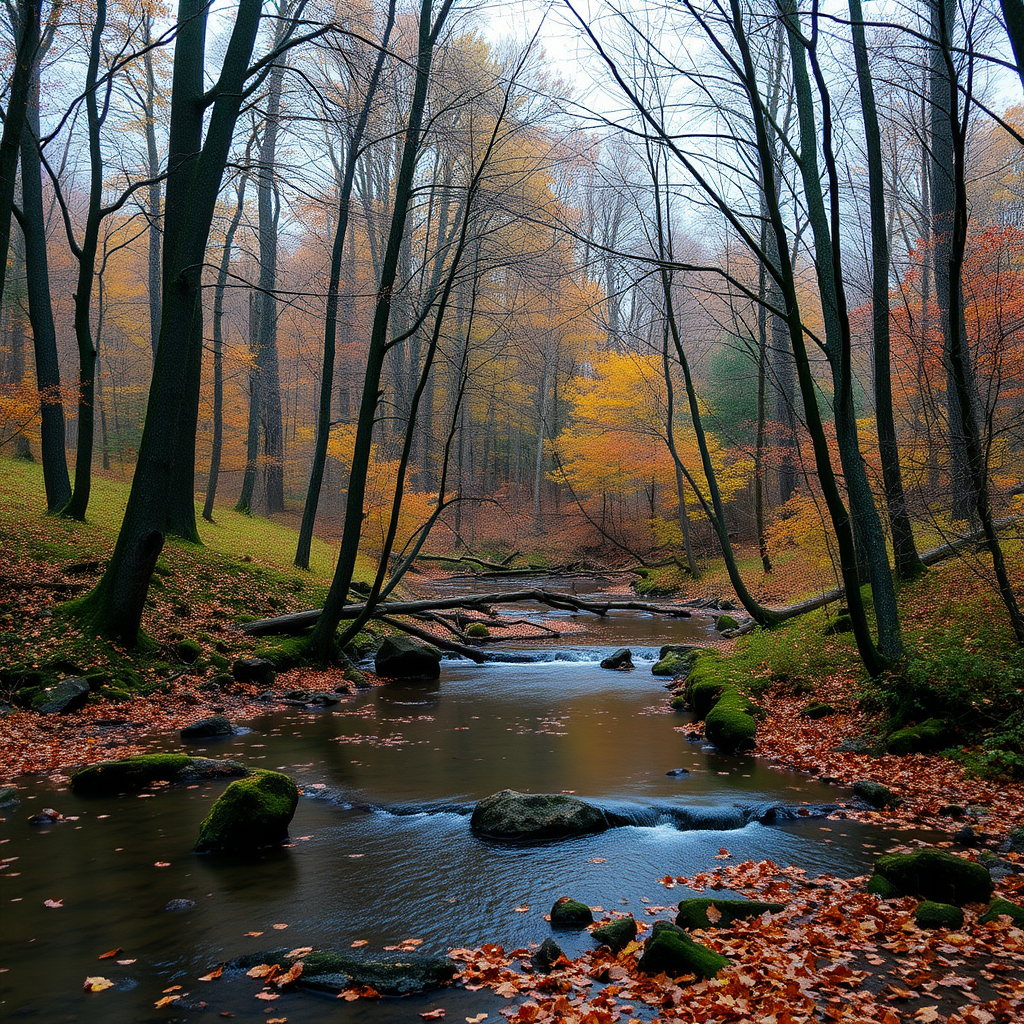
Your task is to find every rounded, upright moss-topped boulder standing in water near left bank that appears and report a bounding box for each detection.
[195,771,299,853]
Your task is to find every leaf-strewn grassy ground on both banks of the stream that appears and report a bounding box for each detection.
[0,462,1024,1024]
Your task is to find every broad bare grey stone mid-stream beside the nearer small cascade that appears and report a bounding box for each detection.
[470,790,609,841]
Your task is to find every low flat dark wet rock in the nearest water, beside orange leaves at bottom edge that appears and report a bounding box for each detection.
[299,950,458,995]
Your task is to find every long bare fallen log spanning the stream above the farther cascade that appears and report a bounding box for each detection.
[242,590,692,637]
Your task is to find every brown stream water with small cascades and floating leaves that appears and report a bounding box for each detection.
[0,581,917,1024]
